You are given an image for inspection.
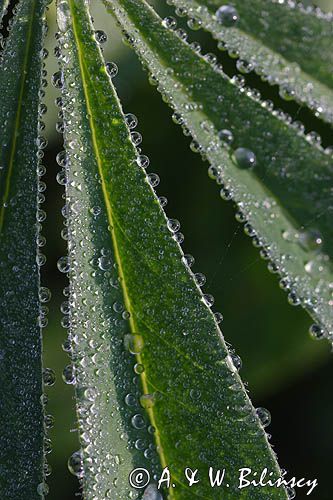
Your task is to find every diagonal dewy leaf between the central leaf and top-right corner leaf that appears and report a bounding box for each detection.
[105,0,333,338]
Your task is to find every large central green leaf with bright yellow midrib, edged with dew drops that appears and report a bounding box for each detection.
[58,0,286,499]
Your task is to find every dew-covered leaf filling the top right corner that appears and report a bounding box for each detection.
[167,0,333,123]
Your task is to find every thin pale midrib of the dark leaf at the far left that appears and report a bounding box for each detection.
[0,0,37,237]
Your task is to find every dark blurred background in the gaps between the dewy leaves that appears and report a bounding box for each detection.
[35,2,333,500]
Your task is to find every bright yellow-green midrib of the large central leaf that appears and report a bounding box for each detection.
[69,0,175,499]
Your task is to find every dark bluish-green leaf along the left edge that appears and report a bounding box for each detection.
[0,0,45,500]
